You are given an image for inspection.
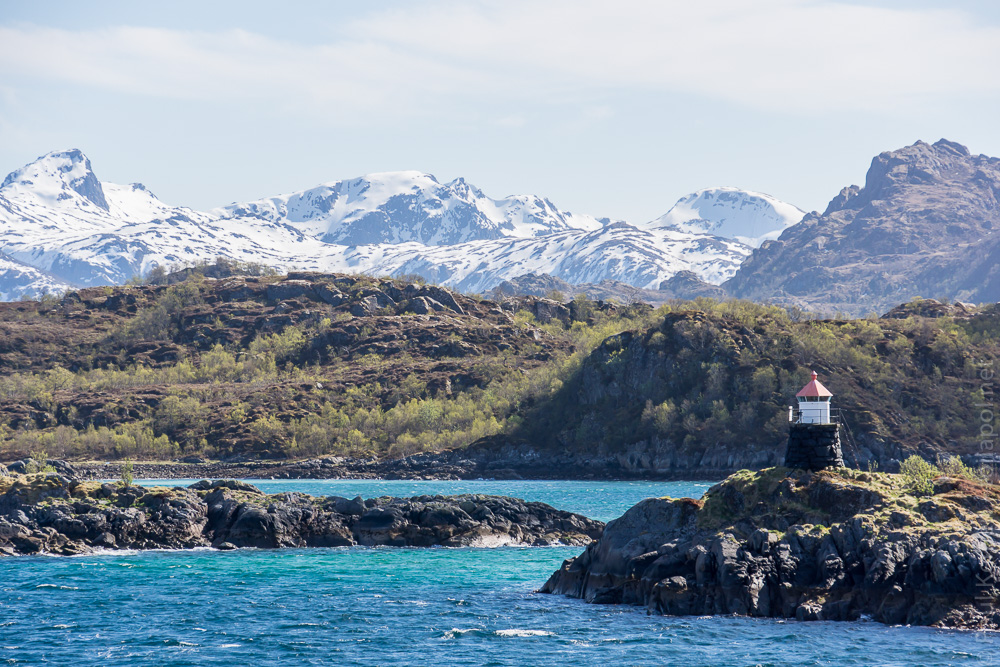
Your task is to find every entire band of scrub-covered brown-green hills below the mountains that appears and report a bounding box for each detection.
[0,267,1000,476]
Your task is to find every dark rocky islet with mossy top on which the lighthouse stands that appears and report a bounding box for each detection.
[542,468,1000,629]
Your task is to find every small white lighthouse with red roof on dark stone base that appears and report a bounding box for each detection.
[785,371,844,470]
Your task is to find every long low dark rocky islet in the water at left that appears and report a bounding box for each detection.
[0,473,603,555]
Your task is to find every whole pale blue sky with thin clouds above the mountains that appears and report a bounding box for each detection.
[0,0,1000,222]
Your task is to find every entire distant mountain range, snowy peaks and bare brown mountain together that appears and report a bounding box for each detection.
[0,139,1000,315]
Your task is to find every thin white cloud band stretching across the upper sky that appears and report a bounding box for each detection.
[0,0,1000,120]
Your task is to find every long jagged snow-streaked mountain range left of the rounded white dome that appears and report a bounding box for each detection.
[0,150,797,299]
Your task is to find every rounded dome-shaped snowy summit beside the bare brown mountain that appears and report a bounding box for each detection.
[642,187,805,248]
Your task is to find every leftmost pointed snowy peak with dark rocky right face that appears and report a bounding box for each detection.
[0,148,108,211]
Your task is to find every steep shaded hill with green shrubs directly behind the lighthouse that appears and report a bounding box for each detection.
[484,300,1000,474]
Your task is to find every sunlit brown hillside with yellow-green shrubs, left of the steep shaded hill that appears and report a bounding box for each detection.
[0,264,652,460]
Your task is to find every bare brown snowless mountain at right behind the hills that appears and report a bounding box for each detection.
[723,139,1000,314]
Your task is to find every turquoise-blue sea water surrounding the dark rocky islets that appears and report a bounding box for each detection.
[0,480,1000,666]
